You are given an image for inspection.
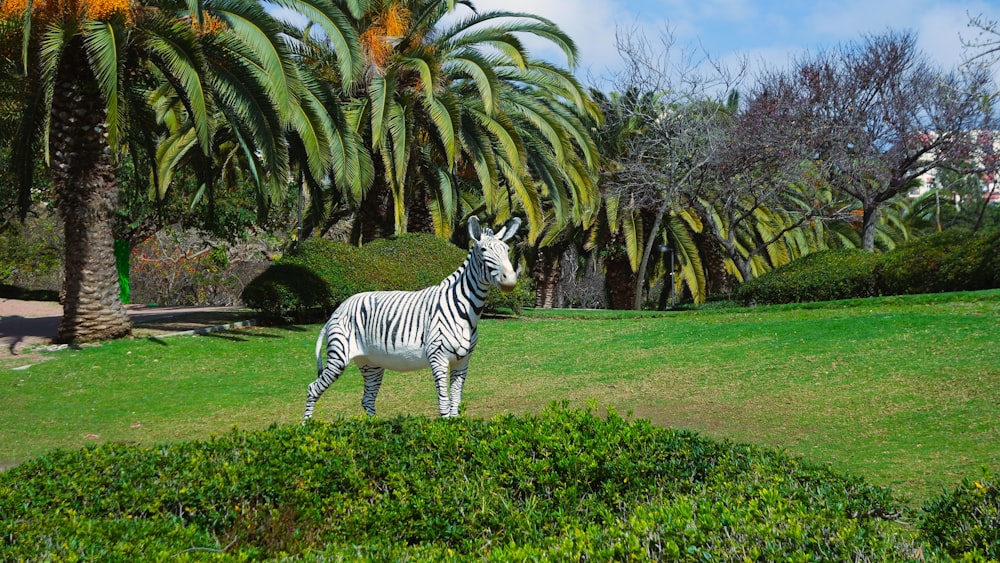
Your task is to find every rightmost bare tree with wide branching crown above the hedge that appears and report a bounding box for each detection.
[788,31,994,250]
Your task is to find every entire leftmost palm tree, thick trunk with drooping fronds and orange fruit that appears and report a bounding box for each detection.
[0,0,360,342]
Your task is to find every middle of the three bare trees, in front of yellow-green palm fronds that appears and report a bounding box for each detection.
[683,65,860,281]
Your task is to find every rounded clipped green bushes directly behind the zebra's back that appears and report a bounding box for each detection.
[242,234,466,320]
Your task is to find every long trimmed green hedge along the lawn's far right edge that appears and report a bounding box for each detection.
[736,230,1000,304]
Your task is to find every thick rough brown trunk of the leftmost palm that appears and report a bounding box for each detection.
[51,40,132,343]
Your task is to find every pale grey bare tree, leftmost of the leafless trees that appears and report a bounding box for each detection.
[598,25,742,309]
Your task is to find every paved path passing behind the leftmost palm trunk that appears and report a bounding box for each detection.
[0,298,253,357]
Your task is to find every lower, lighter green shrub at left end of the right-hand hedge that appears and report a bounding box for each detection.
[736,248,878,305]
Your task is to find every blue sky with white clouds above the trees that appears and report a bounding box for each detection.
[464,0,1000,85]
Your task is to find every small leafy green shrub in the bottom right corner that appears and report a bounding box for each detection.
[920,473,1000,561]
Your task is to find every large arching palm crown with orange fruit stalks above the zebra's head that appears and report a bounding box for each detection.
[351,0,599,240]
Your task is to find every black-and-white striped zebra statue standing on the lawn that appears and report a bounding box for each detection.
[303,217,521,422]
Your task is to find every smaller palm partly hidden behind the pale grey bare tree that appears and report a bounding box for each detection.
[595,88,720,309]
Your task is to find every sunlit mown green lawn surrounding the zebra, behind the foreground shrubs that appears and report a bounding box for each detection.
[0,291,1000,503]
